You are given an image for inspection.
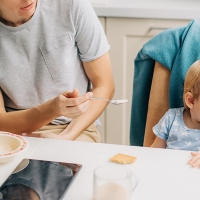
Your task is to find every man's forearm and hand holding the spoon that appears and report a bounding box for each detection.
[0,89,91,134]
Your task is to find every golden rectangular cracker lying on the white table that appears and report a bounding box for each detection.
[109,153,137,164]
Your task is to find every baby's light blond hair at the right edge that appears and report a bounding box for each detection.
[183,60,200,109]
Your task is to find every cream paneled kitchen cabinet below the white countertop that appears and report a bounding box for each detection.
[99,17,190,145]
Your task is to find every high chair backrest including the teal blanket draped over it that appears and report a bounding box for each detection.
[130,20,200,146]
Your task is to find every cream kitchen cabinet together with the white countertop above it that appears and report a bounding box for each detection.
[89,0,200,145]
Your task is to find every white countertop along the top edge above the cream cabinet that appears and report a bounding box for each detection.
[92,0,200,19]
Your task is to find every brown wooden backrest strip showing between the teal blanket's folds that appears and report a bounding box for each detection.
[143,62,170,147]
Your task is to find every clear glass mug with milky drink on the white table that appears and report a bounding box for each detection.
[93,165,138,200]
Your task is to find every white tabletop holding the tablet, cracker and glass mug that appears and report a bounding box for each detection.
[0,138,200,200]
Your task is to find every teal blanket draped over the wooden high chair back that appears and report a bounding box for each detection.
[130,20,200,146]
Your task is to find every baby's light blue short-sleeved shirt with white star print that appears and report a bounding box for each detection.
[153,108,200,151]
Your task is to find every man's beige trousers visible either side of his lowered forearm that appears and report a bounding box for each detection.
[33,123,101,142]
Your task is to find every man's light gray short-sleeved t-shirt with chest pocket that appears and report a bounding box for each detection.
[0,0,110,123]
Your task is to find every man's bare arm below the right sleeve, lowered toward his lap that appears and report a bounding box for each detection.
[61,53,114,140]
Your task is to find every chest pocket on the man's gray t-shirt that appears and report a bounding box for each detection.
[40,35,73,79]
